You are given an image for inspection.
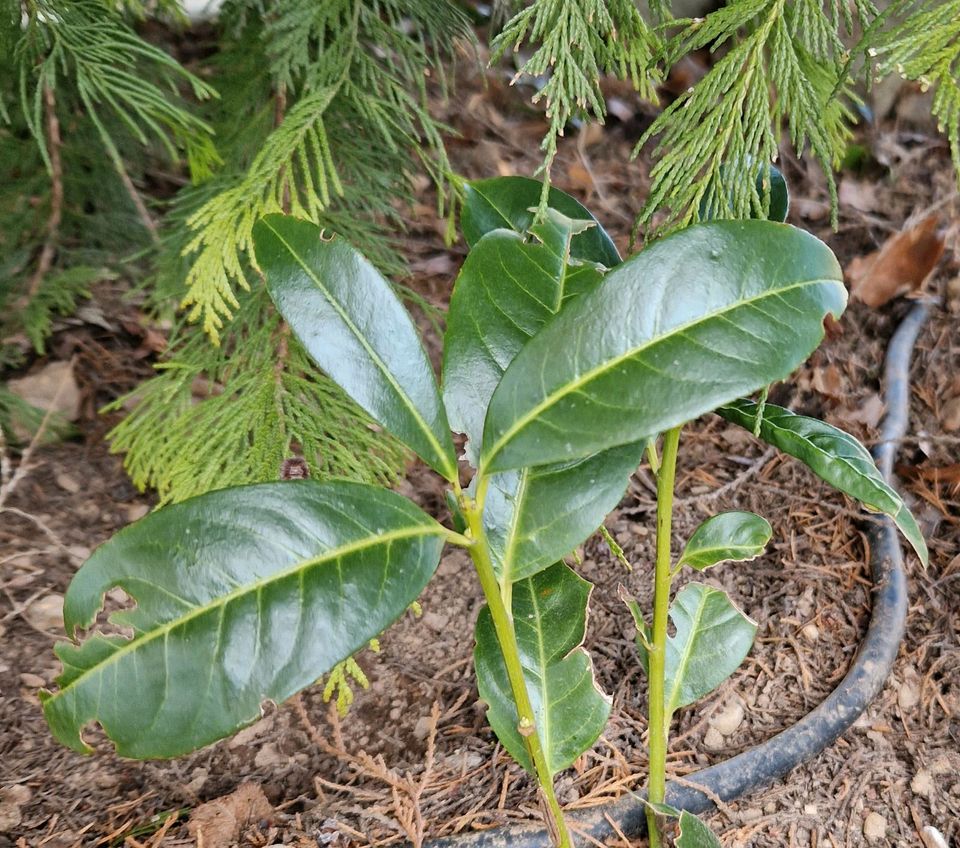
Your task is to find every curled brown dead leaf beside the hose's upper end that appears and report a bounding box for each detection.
[847,215,945,308]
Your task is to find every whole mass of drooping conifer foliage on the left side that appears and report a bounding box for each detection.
[0,0,472,502]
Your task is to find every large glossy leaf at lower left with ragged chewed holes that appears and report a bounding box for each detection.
[43,480,447,758]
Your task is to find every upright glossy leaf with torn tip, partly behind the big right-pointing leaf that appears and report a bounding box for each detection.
[443,210,642,581]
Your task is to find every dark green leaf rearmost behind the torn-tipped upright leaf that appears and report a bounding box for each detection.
[460,172,620,268]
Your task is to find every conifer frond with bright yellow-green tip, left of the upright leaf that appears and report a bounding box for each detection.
[182,0,467,344]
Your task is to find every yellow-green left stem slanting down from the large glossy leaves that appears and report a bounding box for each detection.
[460,484,573,848]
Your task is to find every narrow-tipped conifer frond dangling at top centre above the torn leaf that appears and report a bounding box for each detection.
[492,0,660,209]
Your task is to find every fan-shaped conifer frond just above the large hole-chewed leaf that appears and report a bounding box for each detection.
[108,289,405,503]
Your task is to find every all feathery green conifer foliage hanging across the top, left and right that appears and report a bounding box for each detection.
[0,0,960,502]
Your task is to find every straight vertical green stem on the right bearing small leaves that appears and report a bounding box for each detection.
[647,427,681,848]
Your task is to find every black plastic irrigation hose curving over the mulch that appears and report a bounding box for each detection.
[426,303,930,848]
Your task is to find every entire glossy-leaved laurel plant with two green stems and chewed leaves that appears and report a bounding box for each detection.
[43,178,926,848]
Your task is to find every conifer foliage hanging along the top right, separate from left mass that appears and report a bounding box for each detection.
[494,0,960,234]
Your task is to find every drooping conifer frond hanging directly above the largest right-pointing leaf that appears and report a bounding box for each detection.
[634,0,854,233]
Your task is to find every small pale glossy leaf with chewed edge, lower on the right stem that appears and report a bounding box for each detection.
[663,583,757,717]
